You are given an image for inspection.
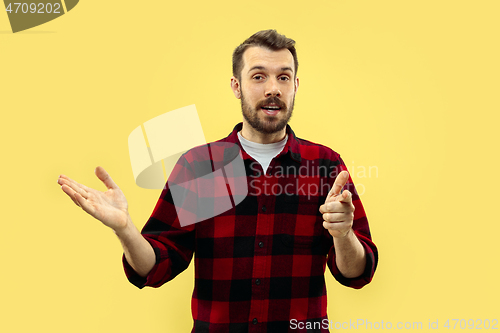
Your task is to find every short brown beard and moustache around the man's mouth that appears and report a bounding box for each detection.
[241,92,295,134]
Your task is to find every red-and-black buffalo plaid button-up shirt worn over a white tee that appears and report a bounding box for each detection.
[123,123,378,332]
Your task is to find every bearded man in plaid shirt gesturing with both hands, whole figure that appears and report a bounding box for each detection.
[59,30,378,332]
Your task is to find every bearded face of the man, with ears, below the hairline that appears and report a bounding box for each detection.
[231,46,299,134]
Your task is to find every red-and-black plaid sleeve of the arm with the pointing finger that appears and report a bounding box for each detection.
[327,157,378,289]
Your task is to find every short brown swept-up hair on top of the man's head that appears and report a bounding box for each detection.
[233,29,299,80]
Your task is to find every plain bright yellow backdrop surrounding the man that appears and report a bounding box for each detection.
[0,0,500,333]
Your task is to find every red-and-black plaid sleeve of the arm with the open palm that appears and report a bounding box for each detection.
[122,155,196,288]
